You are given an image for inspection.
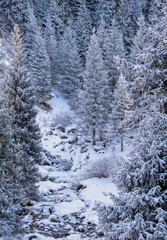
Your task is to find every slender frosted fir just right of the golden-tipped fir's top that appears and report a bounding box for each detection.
[25,8,51,101]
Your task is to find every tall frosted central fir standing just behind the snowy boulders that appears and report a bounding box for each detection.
[80,33,109,145]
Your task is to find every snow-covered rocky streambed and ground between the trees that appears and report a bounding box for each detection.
[24,93,131,240]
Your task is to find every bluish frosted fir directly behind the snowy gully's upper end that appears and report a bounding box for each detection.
[55,26,83,105]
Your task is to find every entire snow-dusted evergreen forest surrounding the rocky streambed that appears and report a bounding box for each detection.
[0,0,167,240]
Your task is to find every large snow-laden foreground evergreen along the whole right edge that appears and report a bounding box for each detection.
[99,3,167,240]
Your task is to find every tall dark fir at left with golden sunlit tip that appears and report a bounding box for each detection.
[5,24,42,199]
